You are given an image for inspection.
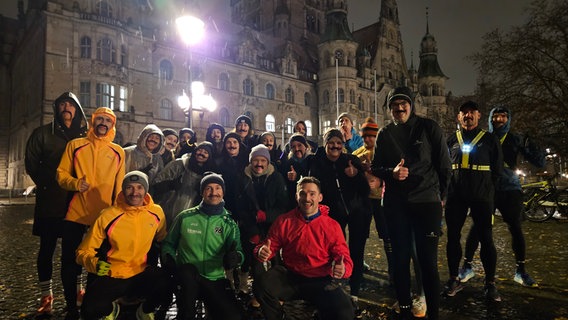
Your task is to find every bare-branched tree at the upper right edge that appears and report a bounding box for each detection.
[470,0,568,157]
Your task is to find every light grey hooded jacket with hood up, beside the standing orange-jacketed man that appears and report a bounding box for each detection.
[124,124,164,184]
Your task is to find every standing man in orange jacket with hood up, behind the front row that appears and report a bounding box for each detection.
[57,107,124,320]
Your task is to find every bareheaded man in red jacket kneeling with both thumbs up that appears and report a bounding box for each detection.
[253,177,355,320]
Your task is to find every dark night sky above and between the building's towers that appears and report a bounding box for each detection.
[0,0,531,95]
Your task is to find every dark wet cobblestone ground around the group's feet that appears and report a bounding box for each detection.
[0,202,568,320]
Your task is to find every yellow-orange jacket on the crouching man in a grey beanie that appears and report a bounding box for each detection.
[77,192,166,279]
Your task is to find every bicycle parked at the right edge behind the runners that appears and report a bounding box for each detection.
[521,175,568,222]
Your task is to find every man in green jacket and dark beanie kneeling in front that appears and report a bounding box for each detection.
[162,173,243,320]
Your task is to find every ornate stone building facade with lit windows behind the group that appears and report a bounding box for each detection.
[0,0,447,189]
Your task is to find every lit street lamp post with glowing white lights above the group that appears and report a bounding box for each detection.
[176,16,205,128]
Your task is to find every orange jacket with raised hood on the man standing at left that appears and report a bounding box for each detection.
[57,107,124,226]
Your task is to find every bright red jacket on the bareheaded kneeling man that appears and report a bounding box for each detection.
[254,205,353,278]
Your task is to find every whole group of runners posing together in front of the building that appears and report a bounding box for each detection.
[25,87,544,320]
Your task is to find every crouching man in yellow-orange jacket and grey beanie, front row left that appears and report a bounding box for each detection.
[77,171,168,320]
